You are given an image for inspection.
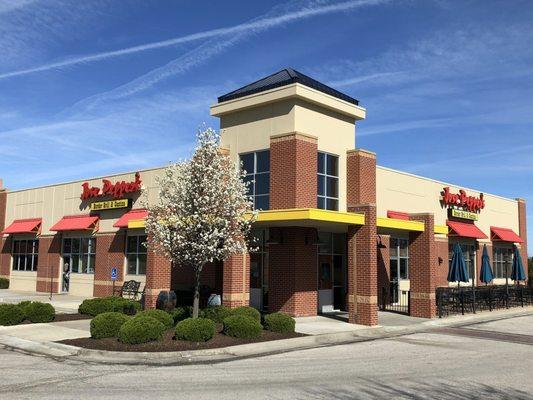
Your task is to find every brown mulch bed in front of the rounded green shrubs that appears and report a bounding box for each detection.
[59,327,306,352]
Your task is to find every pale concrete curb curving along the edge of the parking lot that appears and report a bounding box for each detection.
[0,307,533,366]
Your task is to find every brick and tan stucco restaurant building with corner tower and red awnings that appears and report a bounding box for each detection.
[0,69,527,325]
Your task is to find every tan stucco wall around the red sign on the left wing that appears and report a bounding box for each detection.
[6,168,163,235]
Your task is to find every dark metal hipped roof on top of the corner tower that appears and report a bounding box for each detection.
[218,67,359,105]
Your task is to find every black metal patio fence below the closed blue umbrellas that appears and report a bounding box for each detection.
[436,285,533,318]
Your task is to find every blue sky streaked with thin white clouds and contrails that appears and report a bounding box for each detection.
[0,0,533,255]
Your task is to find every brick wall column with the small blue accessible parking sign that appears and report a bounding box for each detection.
[93,231,126,297]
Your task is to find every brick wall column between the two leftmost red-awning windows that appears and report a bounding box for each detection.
[36,235,62,293]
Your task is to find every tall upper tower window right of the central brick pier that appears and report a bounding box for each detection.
[317,152,339,210]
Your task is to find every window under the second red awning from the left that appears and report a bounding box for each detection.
[63,238,96,274]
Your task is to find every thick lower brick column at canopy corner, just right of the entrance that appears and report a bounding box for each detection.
[347,204,378,326]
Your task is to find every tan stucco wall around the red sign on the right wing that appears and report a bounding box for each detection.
[376,166,519,237]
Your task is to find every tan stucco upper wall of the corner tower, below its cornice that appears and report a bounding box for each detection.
[220,92,355,211]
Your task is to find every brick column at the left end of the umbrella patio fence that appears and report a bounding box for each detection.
[409,214,436,318]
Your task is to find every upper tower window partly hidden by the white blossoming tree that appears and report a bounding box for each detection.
[241,150,270,210]
